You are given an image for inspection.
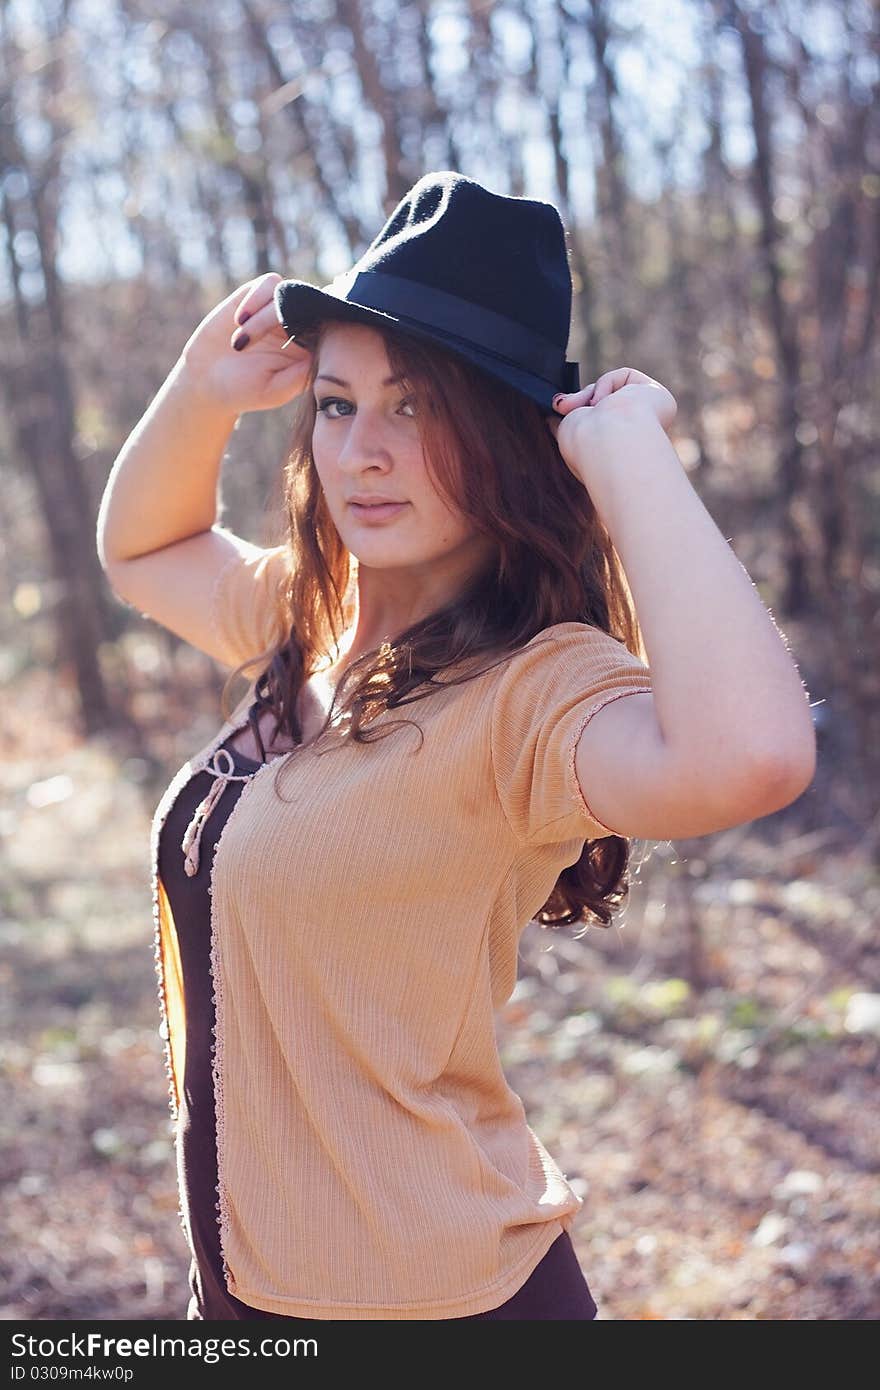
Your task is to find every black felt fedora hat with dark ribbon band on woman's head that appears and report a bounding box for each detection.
[274,170,580,411]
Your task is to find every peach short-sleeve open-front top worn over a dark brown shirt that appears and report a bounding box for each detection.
[152,528,651,1319]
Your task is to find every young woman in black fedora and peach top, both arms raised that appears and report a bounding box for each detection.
[92,171,815,1321]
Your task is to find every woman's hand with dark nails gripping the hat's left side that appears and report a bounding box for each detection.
[179,271,311,414]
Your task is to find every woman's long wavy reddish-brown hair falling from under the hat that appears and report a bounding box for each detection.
[221,321,645,926]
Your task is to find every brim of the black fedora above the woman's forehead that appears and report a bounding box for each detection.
[274,279,559,414]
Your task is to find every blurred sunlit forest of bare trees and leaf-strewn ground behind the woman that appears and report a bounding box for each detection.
[0,0,880,1319]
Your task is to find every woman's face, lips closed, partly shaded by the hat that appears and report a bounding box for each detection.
[311,324,487,577]
